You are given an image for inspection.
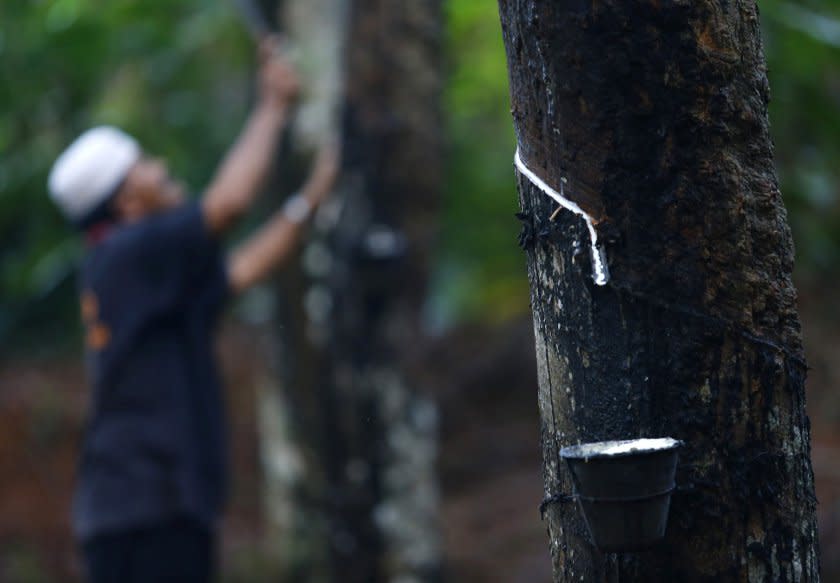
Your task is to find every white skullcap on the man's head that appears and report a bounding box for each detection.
[49,126,141,223]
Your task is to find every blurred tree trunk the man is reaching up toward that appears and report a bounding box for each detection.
[261,0,442,583]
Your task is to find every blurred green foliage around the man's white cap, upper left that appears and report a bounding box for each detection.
[0,0,252,344]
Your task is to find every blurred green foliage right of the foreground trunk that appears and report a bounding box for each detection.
[760,0,840,275]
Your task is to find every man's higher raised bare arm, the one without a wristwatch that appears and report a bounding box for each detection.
[201,39,300,234]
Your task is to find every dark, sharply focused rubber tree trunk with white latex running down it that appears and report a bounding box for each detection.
[499,0,819,582]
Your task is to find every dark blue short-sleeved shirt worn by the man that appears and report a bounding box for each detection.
[73,204,228,539]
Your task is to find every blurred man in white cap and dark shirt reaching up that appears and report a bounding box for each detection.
[49,40,337,583]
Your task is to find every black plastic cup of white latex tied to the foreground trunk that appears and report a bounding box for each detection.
[560,437,682,553]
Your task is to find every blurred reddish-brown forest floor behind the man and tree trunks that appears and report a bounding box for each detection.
[0,286,840,583]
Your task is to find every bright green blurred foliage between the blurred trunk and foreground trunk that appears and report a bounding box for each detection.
[434,0,528,328]
